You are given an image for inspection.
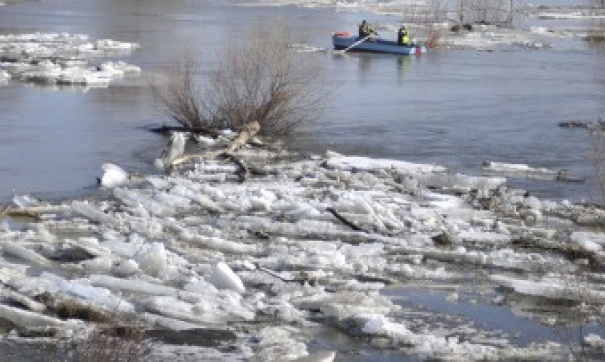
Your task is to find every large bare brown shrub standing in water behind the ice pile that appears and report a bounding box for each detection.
[156,21,328,135]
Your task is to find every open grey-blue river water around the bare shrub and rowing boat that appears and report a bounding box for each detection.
[0,0,605,204]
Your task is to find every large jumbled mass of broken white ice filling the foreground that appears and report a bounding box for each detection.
[0,137,605,360]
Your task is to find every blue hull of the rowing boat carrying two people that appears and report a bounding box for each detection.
[332,33,427,55]
